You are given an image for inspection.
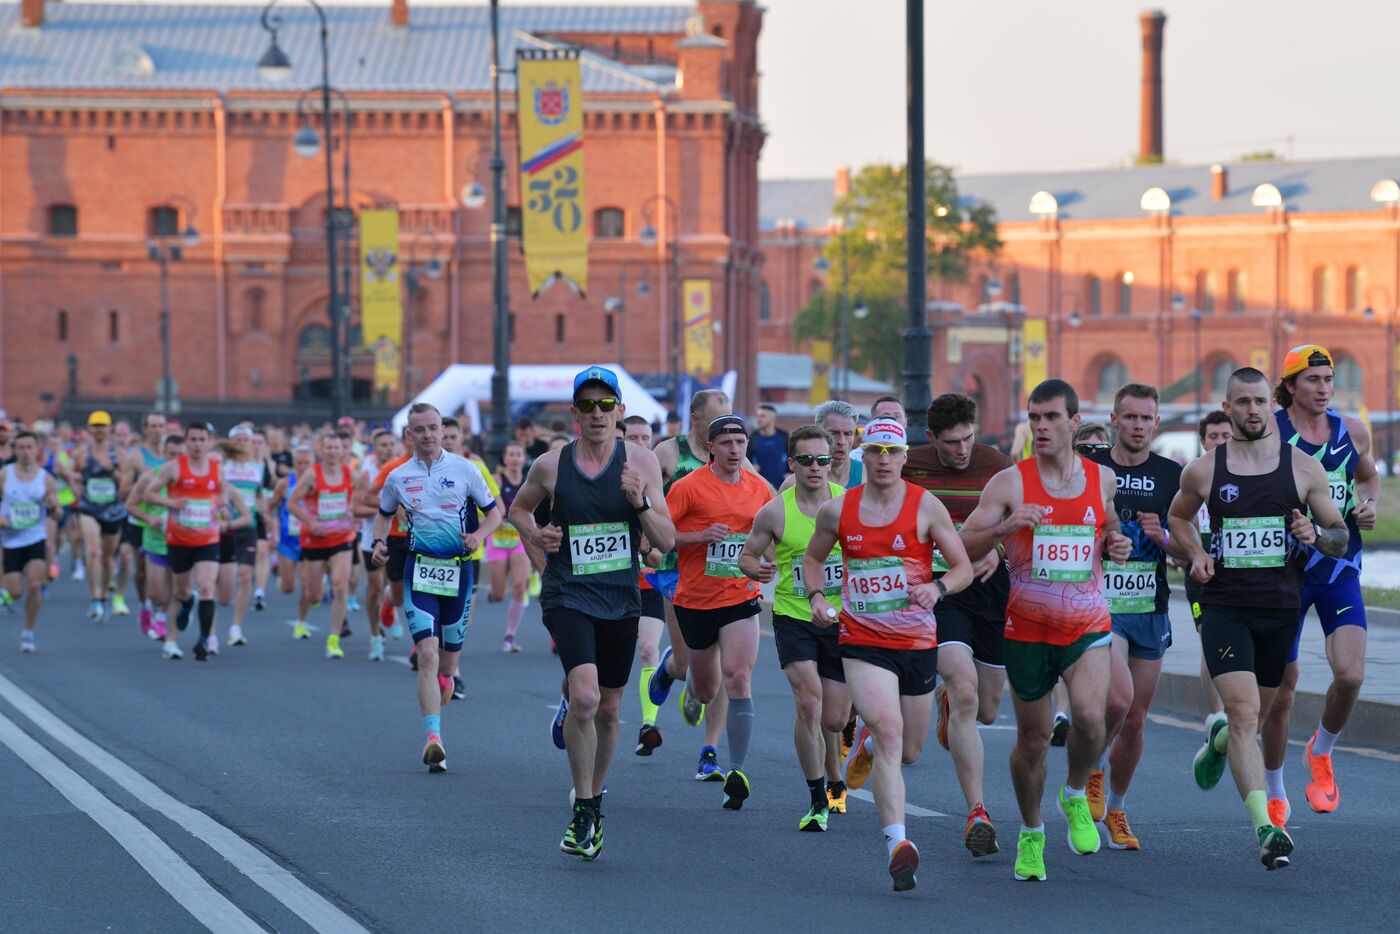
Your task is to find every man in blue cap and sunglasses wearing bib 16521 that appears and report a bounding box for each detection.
[510,367,675,860]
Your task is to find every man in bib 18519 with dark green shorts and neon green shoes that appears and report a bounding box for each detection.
[962,379,1133,881]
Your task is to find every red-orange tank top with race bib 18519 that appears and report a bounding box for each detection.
[1007,456,1112,646]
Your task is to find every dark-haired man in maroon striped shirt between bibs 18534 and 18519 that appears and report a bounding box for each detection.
[901,392,1012,858]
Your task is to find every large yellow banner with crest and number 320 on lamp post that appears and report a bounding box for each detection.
[515,49,588,295]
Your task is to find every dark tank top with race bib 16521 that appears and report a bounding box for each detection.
[539,438,641,619]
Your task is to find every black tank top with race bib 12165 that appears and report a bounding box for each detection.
[1201,442,1306,609]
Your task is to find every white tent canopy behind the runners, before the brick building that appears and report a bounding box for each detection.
[393,363,666,434]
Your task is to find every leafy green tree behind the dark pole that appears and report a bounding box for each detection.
[792,162,1001,385]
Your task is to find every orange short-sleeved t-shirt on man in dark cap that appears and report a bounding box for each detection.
[666,465,773,609]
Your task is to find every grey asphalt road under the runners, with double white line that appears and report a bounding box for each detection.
[0,581,1400,933]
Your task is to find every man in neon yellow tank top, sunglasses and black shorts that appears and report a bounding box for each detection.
[739,424,851,832]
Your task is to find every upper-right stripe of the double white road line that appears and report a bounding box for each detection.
[0,675,364,931]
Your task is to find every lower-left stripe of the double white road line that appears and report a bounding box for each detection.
[0,714,263,933]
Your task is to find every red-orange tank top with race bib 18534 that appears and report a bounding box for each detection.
[836,480,938,650]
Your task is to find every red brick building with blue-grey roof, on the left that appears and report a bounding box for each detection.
[0,0,764,416]
